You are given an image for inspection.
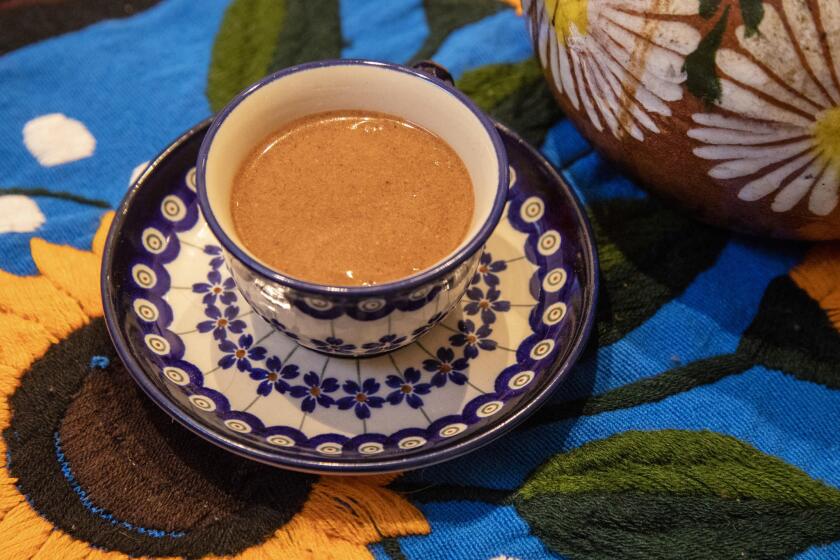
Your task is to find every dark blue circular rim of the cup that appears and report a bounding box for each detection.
[196,59,509,297]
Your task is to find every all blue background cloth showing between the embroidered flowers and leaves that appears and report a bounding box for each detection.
[0,0,840,560]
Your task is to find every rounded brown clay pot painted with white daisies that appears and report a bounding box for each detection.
[523,0,840,239]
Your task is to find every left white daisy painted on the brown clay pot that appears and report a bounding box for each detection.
[523,0,700,140]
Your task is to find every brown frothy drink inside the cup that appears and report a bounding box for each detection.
[231,110,474,286]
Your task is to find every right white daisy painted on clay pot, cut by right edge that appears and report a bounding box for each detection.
[688,0,840,216]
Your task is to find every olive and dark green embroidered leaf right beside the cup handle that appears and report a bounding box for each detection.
[457,59,562,146]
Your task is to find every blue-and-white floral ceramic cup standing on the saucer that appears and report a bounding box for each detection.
[196,60,508,356]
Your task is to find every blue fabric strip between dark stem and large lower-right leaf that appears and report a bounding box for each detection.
[410,367,840,489]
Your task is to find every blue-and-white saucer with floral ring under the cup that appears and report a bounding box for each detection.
[102,118,597,473]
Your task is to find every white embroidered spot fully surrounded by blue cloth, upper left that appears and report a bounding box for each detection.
[23,113,96,167]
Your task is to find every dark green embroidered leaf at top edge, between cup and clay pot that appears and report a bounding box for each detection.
[412,0,506,60]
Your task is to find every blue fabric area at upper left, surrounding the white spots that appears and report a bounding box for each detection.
[0,0,227,274]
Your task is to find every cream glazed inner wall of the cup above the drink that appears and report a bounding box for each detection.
[197,60,507,294]
